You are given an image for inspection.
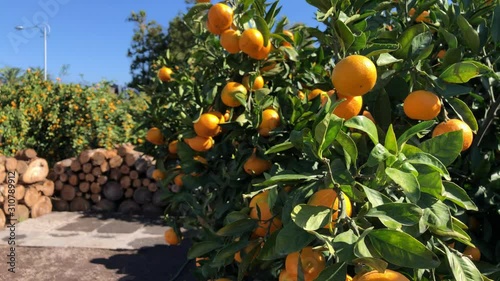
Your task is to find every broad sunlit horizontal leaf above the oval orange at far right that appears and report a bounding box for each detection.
[439,61,491,84]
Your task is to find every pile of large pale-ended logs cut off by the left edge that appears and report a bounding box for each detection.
[0,149,54,227]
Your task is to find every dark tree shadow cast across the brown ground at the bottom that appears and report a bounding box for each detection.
[90,240,196,281]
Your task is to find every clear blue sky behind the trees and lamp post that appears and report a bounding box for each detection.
[0,0,318,86]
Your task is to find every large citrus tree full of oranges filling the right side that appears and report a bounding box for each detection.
[142,0,500,281]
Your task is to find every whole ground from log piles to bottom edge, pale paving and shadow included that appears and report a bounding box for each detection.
[0,212,195,281]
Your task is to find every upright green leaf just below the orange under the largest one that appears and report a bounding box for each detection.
[314,113,343,157]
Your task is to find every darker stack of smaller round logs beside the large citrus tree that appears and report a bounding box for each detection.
[53,145,164,214]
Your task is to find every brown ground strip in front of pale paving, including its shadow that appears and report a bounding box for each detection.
[0,241,195,281]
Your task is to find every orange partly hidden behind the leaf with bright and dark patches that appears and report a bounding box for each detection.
[307,188,352,228]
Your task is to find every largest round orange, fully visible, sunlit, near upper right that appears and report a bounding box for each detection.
[331,55,377,96]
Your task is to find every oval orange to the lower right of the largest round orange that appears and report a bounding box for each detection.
[403,90,441,120]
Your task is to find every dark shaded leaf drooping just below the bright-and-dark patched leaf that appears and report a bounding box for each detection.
[259,223,315,260]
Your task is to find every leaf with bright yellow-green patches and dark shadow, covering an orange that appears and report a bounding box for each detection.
[292,204,332,230]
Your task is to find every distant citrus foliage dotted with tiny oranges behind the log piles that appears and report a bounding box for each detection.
[0,69,147,163]
